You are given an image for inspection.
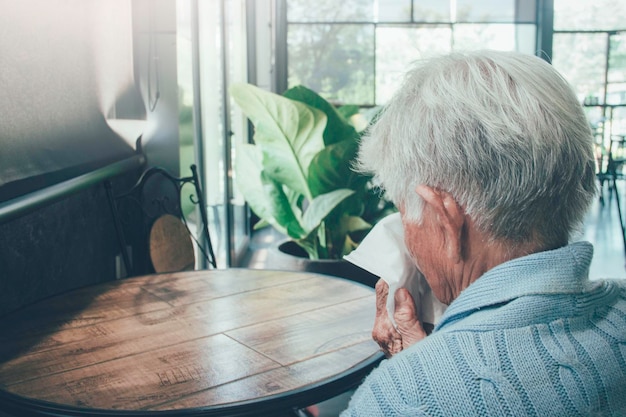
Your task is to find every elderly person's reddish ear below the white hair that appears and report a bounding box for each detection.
[415,184,465,263]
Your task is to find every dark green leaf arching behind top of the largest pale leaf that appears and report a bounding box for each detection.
[283,85,358,146]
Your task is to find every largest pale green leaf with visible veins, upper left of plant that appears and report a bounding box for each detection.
[230,84,326,199]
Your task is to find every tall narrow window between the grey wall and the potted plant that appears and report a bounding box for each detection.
[177,0,249,267]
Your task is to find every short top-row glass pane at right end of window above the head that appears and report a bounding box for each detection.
[456,0,535,23]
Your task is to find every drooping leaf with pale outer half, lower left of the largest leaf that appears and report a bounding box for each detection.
[234,143,305,238]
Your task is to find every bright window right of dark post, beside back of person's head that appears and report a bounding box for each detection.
[552,0,626,153]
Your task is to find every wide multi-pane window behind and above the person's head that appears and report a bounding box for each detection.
[279,0,541,106]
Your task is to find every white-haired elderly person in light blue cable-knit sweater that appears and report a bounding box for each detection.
[342,51,626,417]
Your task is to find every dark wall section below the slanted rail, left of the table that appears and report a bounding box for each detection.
[0,172,137,315]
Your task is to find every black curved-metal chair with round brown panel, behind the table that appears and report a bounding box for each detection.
[105,165,217,276]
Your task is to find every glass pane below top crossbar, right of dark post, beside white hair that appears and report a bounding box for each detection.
[552,33,607,103]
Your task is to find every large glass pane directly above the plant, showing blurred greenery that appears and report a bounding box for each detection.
[287,24,374,105]
